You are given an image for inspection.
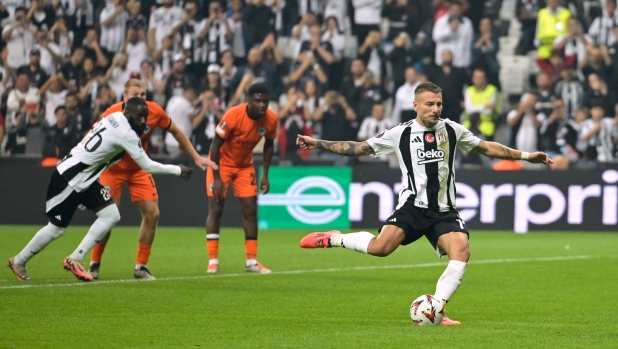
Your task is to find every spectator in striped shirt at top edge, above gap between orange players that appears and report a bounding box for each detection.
[200,1,234,64]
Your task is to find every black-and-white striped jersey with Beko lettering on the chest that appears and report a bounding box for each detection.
[367,119,481,212]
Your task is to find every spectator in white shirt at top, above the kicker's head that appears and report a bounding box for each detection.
[432,1,474,68]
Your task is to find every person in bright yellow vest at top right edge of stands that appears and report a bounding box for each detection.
[534,0,571,59]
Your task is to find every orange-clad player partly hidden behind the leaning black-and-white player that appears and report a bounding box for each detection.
[89,79,213,280]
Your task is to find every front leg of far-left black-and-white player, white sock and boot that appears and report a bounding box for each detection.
[62,202,120,281]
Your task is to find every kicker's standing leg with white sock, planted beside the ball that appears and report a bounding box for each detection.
[434,232,470,326]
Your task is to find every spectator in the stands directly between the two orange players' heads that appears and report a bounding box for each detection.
[192,90,223,155]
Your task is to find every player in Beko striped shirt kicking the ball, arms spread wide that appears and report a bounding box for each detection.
[296,82,553,325]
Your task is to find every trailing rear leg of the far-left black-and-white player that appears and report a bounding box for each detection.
[7,222,66,281]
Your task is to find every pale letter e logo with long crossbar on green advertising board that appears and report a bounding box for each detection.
[258,176,347,224]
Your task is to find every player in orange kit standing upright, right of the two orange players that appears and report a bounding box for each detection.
[206,84,278,274]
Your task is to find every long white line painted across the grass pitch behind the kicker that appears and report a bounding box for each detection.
[0,256,596,290]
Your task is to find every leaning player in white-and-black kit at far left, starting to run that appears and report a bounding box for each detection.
[8,97,193,281]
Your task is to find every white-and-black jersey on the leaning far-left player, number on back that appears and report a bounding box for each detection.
[57,112,180,192]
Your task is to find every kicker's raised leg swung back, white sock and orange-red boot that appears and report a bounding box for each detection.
[300,225,405,257]
